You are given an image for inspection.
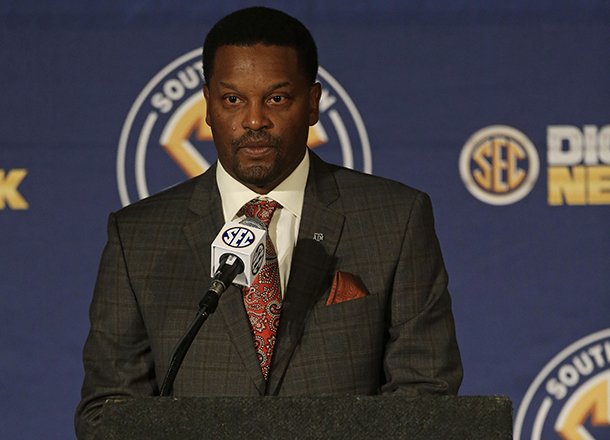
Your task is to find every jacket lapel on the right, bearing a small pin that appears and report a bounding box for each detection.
[266,153,345,395]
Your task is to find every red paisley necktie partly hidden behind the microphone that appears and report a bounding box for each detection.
[240,199,282,380]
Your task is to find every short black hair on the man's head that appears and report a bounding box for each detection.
[203,6,318,84]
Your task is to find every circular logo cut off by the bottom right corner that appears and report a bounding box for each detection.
[514,328,610,440]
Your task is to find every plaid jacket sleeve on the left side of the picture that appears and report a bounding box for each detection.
[75,214,158,440]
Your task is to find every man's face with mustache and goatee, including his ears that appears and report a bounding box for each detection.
[203,44,320,194]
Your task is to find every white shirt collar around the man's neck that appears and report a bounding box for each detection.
[216,150,309,221]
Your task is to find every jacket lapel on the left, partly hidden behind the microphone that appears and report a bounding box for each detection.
[184,165,265,394]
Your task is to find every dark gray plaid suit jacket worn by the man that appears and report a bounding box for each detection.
[76,154,462,438]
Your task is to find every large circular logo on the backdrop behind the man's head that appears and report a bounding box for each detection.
[116,49,372,205]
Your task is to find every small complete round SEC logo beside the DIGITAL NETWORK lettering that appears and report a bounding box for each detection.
[460,125,540,205]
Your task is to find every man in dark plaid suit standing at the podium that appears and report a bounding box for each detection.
[76,8,462,438]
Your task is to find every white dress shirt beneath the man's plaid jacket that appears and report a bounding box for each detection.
[216,151,309,297]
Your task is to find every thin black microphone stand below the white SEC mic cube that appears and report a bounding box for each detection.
[159,254,244,397]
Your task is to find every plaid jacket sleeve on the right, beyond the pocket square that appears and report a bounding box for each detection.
[381,193,462,396]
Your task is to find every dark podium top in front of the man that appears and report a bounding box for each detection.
[98,396,512,440]
